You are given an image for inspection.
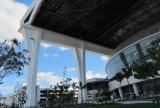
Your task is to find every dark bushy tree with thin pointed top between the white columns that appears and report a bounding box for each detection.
[40,67,76,108]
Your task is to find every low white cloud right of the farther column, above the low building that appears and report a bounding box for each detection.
[86,71,107,79]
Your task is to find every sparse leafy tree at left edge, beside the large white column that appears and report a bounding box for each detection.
[0,39,27,83]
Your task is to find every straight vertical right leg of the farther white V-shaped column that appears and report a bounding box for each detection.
[81,43,87,102]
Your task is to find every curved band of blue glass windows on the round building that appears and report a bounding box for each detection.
[106,36,160,79]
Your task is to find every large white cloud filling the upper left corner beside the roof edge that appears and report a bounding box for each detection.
[0,0,28,42]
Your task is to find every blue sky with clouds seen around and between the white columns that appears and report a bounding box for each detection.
[0,0,108,95]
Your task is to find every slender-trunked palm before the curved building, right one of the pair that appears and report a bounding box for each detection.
[122,68,132,100]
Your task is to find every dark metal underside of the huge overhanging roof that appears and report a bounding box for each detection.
[29,0,160,49]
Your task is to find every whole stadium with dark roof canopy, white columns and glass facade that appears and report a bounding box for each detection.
[19,0,160,108]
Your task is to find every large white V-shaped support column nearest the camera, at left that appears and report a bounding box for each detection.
[22,28,42,108]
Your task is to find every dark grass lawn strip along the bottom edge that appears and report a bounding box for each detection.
[49,103,160,108]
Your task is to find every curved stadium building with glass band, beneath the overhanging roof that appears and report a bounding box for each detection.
[105,24,160,98]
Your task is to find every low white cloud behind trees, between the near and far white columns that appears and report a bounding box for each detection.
[37,72,78,85]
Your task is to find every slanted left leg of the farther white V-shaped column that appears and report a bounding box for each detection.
[73,48,82,103]
